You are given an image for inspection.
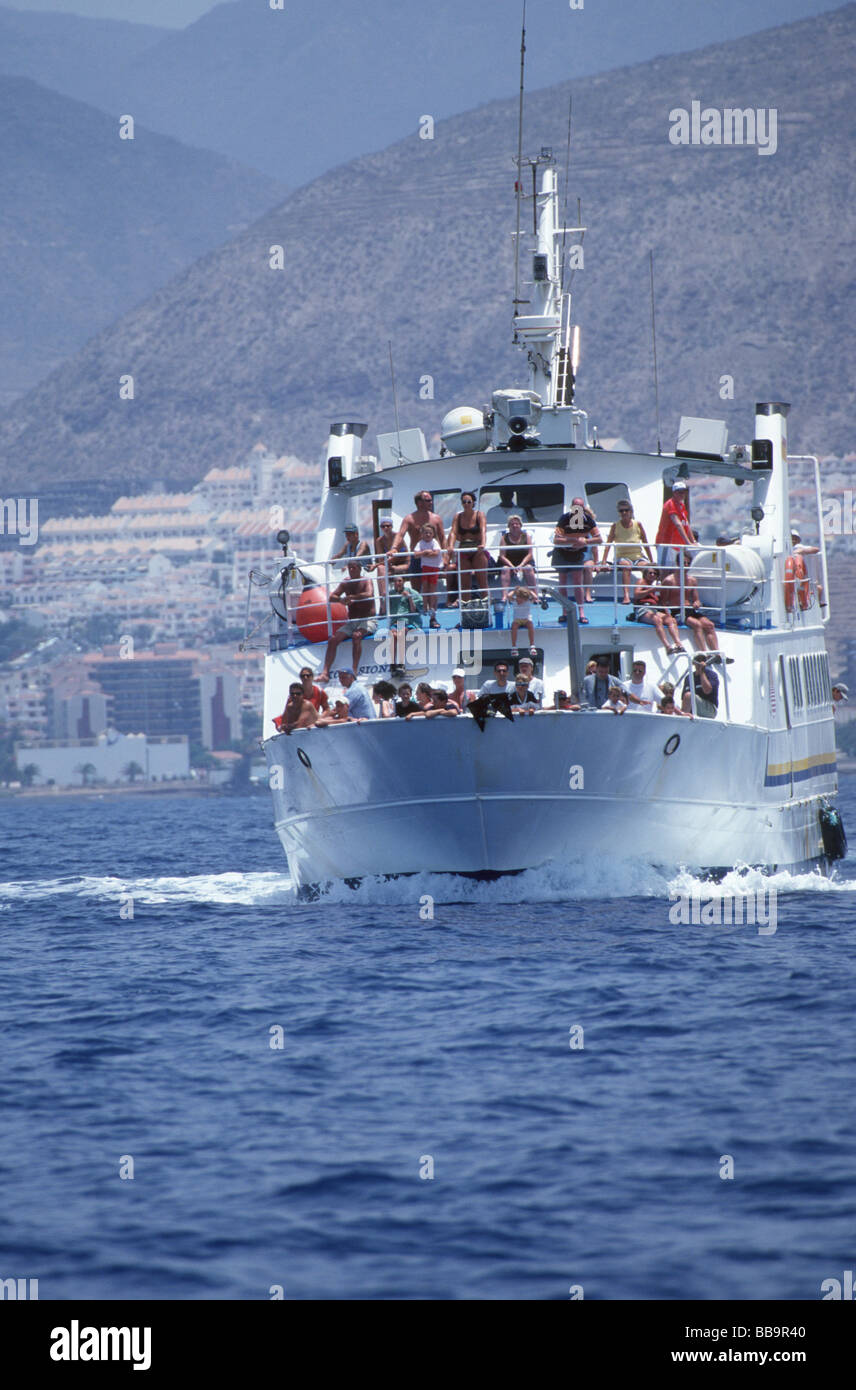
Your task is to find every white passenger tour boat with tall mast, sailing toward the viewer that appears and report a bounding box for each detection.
[247,86,846,892]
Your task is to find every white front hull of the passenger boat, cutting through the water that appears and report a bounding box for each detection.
[265,713,835,888]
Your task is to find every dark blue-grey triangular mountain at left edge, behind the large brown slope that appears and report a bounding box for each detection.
[0,76,283,403]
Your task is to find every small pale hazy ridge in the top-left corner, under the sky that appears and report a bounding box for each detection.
[0,6,171,111]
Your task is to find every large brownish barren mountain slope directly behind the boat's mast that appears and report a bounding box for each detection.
[0,4,856,492]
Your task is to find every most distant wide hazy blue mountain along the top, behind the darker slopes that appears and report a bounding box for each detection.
[0,0,823,188]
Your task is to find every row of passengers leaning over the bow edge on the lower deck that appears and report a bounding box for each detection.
[274,652,721,734]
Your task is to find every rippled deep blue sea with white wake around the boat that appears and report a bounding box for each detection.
[0,777,856,1300]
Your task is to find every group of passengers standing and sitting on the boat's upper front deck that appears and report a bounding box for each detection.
[318,478,750,684]
